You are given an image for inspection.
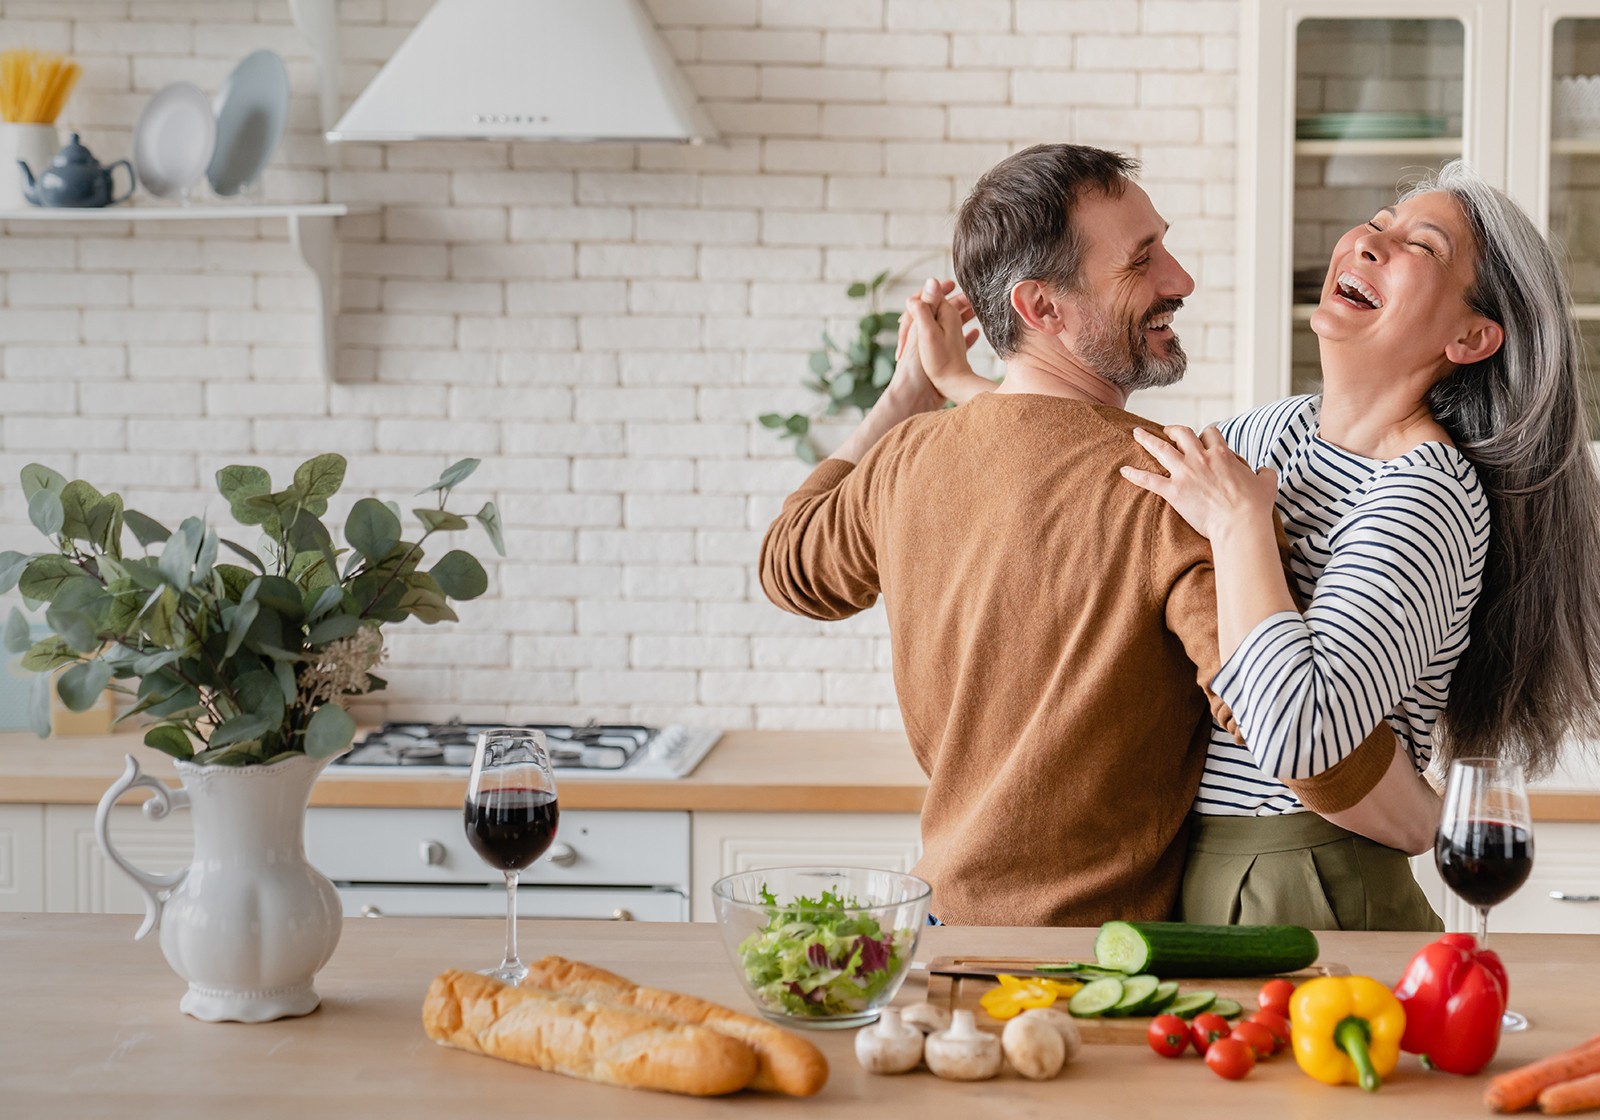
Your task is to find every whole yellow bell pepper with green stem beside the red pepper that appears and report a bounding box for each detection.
[1290,976,1405,1093]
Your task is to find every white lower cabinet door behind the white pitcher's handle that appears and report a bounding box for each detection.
[45,805,194,914]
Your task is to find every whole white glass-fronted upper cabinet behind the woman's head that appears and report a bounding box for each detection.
[1235,0,1600,410]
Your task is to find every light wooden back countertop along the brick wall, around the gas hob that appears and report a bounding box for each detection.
[0,731,1600,821]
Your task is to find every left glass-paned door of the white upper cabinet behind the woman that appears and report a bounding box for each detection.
[1235,0,1509,410]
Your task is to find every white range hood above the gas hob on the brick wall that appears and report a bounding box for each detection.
[328,0,717,144]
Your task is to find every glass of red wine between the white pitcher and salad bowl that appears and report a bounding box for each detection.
[466,728,560,986]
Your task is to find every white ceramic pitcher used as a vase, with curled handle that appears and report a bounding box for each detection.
[94,755,344,1022]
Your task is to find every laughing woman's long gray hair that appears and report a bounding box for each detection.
[1405,160,1600,774]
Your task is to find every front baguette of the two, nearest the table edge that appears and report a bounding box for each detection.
[422,970,757,1096]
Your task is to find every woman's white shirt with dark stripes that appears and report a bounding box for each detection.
[1195,397,1490,816]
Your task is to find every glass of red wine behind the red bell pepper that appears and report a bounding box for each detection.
[1434,758,1533,1030]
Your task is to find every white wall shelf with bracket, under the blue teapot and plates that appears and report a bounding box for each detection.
[0,202,360,378]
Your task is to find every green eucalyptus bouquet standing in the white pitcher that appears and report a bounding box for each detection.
[0,454,506,766]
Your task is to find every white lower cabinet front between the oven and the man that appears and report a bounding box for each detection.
[690,813,922,922]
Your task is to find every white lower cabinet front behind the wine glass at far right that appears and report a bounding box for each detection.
[1442,821,1600,942]
